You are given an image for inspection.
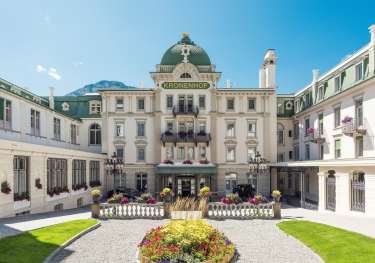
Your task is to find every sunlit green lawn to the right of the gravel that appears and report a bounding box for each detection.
[278,220,375,263]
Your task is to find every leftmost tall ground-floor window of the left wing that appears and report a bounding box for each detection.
[13,156,30,201]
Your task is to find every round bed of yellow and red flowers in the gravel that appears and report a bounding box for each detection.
[138,220,235,263]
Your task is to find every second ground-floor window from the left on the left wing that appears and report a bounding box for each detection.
[47,158,68,192]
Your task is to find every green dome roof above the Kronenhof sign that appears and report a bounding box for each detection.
[160,33,211,66]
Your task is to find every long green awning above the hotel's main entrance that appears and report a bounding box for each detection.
[156,164,217,175]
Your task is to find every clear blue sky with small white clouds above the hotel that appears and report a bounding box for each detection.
[0,0,375,95]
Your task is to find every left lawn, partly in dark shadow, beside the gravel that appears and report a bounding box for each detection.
[0,219,97,263]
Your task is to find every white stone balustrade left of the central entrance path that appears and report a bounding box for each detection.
[99,203,165,219]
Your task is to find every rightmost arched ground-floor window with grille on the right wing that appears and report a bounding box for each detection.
[350,171,365,212]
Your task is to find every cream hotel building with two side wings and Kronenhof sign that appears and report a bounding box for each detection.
[0,26,375,217]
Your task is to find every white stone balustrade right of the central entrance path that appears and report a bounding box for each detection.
[207,202,274,219]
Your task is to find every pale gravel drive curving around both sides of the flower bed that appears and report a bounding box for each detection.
[52,219,322,263]
